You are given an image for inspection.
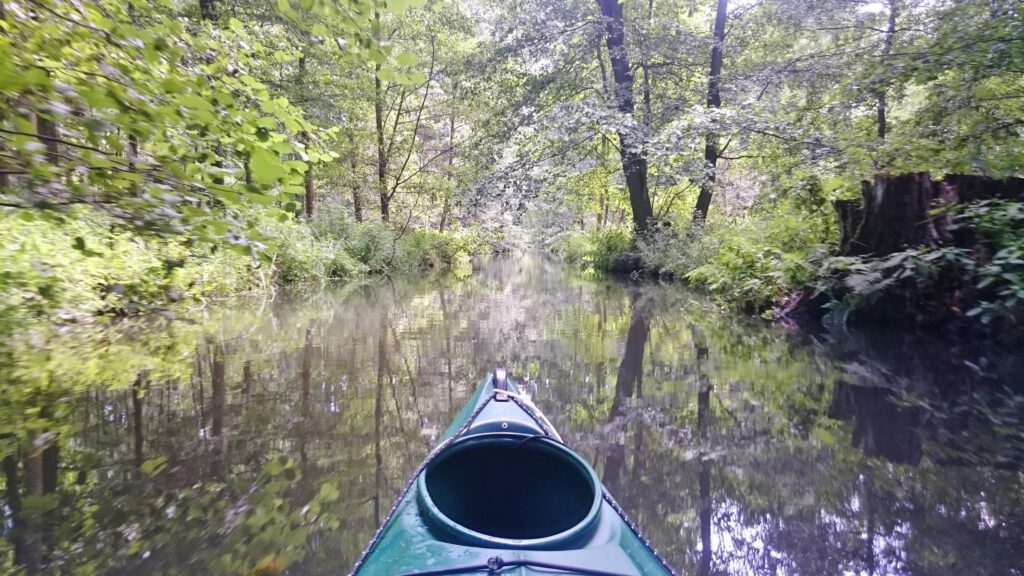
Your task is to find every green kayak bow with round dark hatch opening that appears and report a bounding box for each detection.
[352,370,674,576]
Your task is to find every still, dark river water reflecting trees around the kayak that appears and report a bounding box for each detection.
[0,257,1024,575]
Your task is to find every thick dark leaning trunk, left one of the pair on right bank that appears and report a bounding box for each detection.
[597,0,654,236]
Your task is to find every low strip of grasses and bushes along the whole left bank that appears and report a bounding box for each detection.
[0,207,487,325]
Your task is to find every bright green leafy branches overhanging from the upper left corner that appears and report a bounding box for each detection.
[0,0,344,240]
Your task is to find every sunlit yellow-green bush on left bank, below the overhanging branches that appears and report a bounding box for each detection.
[0,208,259,320]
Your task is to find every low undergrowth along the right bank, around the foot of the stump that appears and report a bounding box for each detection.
[552,194,1024,331]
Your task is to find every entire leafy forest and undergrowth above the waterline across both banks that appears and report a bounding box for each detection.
[0,0,1024,324]
